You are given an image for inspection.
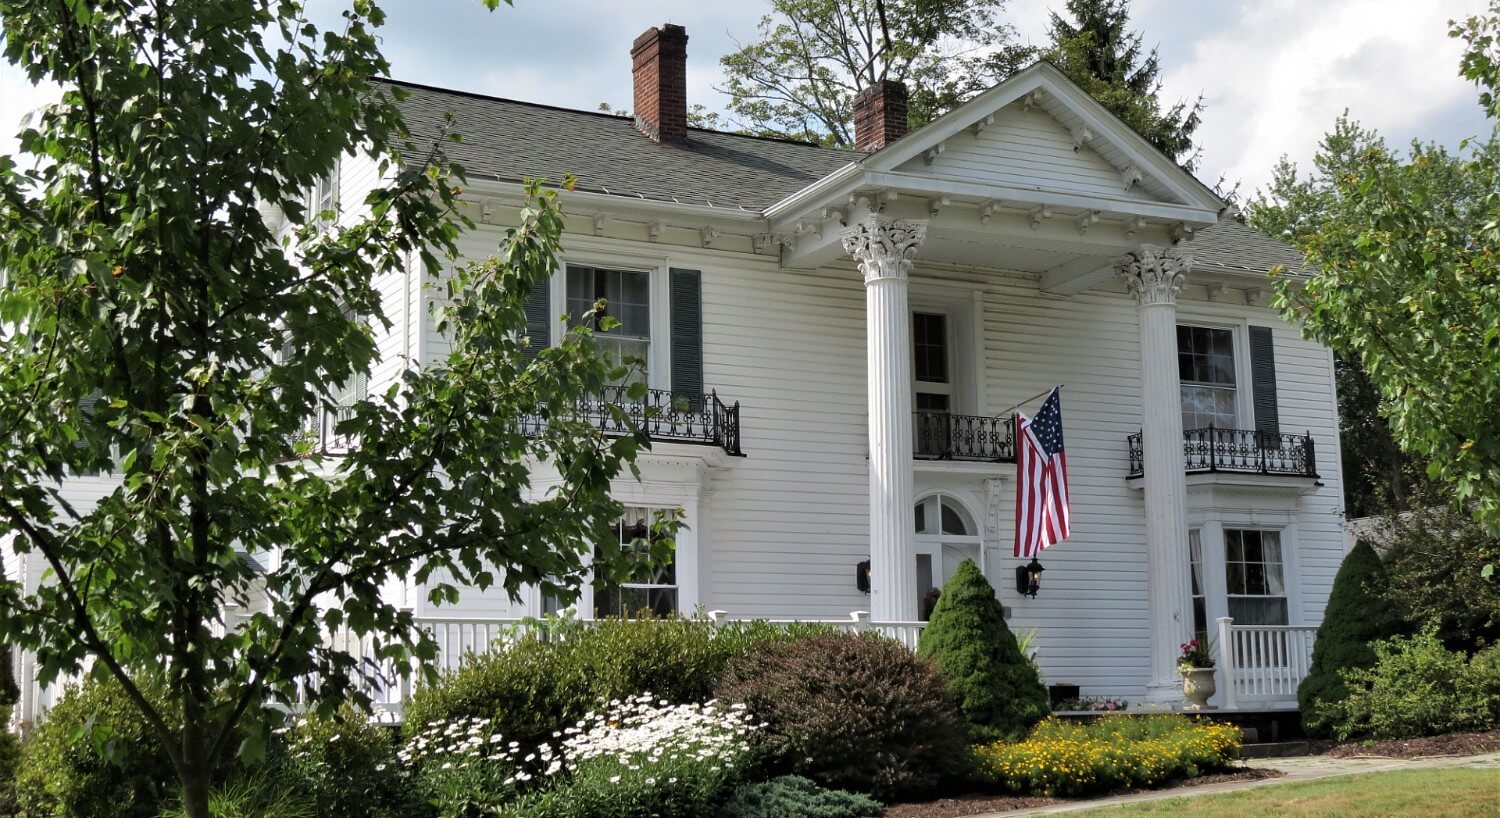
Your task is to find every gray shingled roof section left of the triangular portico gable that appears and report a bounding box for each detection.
[384,80,863,212]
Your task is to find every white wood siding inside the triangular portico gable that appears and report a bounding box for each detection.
[903,105,1160,201]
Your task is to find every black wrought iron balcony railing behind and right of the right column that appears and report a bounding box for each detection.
[1127,426,1317,477]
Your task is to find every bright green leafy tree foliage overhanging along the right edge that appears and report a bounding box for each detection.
[1277,3,1500,549]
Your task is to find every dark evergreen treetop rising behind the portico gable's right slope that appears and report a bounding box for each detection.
[1046,0,1203,170]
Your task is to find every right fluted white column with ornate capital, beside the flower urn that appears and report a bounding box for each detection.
[1121,245,1193,701]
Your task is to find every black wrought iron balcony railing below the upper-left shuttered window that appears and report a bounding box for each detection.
[522,386,744,456]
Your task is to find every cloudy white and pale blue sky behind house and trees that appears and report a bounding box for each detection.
[0,0,1485,192]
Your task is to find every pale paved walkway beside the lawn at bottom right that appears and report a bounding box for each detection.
[974,752,1500,818]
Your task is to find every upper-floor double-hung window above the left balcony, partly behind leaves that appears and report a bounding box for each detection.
[567,264,651,384]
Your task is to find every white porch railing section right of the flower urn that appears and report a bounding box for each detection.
[1218,617,1317,708]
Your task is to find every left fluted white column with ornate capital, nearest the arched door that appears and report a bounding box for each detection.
[843,213,927,621]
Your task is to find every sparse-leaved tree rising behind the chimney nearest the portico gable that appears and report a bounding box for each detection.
[720,0,1026,147]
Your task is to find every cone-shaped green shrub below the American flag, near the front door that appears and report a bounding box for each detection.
[917,560,1050,741]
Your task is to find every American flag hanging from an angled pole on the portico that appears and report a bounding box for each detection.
[1016,389,1068,560]
